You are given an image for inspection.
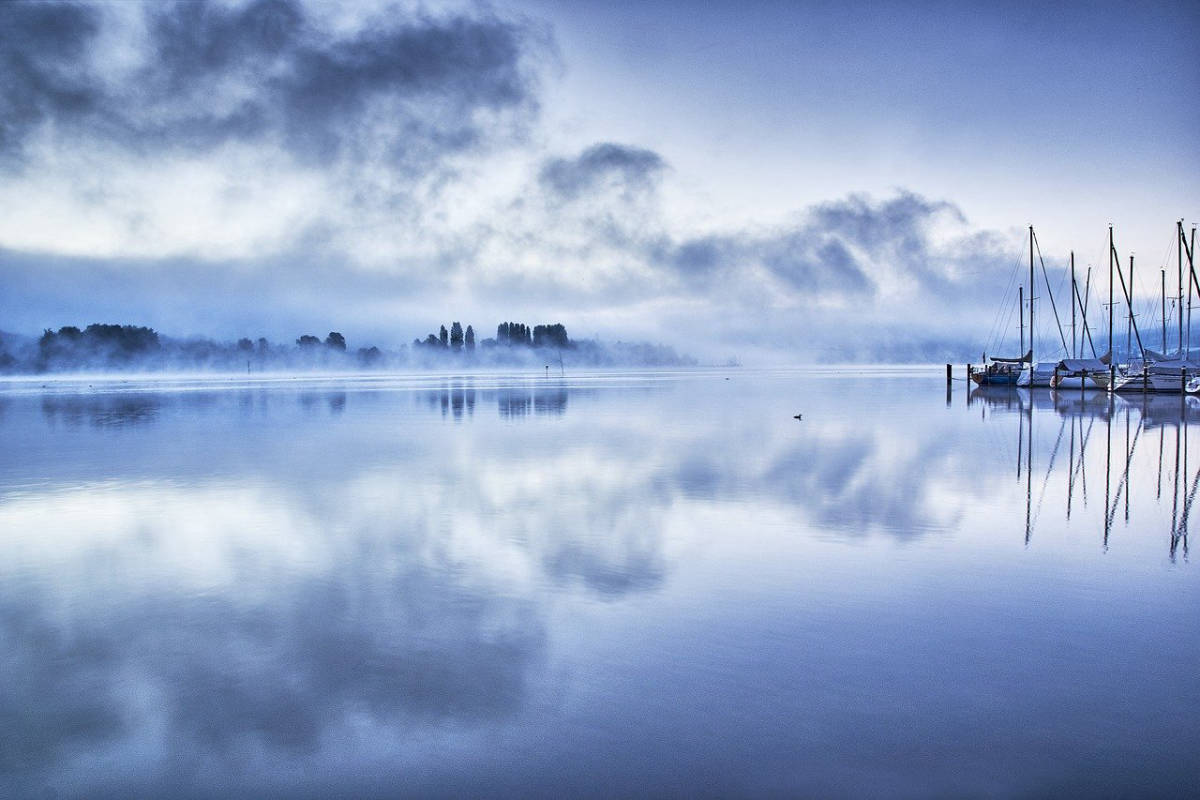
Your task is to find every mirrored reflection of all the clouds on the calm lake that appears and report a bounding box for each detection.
[0,379,1200,794]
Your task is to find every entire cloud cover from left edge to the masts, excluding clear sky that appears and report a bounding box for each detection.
[0,0,1032,357]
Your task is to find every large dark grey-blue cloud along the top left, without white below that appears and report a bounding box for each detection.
[0,0,536,169]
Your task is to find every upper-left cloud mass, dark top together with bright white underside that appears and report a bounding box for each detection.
[0,0,554,269]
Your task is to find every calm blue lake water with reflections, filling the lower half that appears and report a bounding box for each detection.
[0,368,1200,798]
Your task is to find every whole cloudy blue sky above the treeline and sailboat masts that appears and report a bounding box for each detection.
[0,0,1200,361]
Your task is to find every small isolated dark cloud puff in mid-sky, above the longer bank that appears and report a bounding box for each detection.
[538,142,666,200]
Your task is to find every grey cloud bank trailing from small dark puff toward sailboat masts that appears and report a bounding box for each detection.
[528,143,993,309]
